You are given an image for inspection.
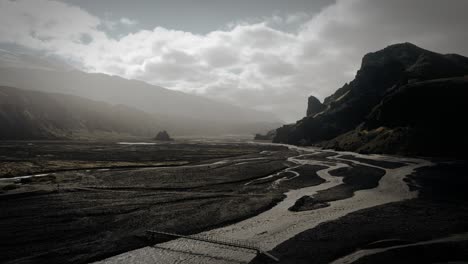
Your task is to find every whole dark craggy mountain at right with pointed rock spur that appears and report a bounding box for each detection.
[274,43,468,157]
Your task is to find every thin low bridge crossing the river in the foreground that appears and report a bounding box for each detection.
[146,230,279,262]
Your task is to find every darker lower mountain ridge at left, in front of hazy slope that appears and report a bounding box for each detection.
[0,86,159,140]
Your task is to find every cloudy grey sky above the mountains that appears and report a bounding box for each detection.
[0,0,468,122]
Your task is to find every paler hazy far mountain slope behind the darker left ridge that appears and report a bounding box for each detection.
[0,58,281,135]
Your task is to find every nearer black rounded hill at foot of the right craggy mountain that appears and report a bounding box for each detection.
[323,77,468,157]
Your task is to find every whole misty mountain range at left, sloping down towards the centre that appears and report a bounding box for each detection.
[0,50,281,139]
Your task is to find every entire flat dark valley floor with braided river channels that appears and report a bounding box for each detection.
[0,141,468,263]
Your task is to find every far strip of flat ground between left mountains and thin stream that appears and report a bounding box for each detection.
[0,141,286,178]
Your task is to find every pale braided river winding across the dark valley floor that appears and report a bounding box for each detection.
[96,145,431,264]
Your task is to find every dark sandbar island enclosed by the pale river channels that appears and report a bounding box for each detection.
[289,164,385,212]
